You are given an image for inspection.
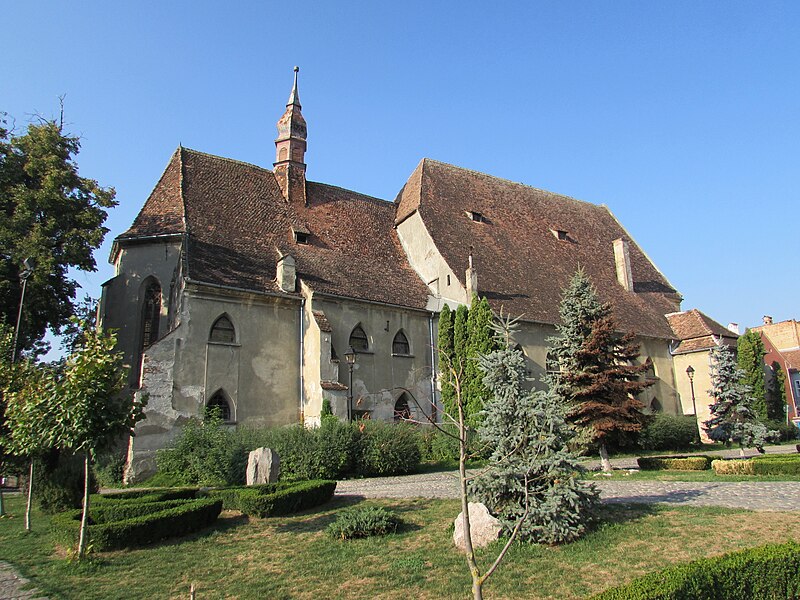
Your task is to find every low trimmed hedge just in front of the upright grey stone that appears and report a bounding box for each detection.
[207,480,336,518]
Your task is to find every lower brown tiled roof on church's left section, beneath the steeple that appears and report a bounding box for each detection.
[118,148,427,308]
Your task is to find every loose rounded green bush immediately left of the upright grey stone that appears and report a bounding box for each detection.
[156,413,247,485]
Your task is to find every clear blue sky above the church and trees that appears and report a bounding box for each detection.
[0,0,800,352]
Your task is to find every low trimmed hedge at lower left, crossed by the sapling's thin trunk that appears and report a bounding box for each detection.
[51,498,222,550]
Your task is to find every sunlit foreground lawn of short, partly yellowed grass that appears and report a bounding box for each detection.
[0,497,800,600]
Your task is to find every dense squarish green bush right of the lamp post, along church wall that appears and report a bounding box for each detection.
[356,421,420,477]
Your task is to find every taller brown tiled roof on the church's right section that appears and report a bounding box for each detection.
[395,159,680,338]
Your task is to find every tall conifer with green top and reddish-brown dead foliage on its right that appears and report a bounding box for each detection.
[545,269,653,471]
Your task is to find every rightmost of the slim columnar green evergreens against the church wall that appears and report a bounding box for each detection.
[464,295,497,427]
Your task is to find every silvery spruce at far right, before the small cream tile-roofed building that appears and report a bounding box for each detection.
[703,346,777,456]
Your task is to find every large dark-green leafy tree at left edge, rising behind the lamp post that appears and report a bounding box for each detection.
[0,115,116,349]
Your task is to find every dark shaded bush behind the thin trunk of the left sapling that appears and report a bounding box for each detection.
[33,450,98,514]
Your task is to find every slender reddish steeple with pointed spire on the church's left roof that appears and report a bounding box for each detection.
[273,67,306,204]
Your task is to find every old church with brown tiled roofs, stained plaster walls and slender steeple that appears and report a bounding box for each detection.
[100,69,708,477]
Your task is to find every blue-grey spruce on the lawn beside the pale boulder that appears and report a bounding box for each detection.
[471,321,598,544]
